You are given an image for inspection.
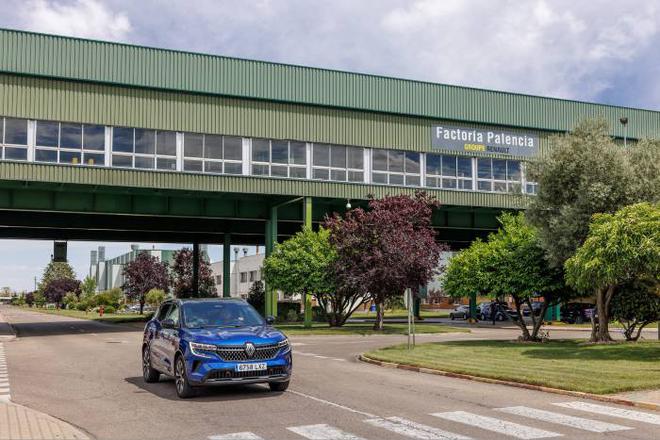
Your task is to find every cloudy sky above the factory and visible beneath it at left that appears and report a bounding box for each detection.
[0,0,660,289]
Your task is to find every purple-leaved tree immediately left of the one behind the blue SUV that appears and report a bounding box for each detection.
[122,252,170,314]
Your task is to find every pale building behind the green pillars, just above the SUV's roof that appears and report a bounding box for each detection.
[211,248,265,298]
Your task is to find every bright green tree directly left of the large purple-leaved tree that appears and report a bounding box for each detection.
[263,227,365,327]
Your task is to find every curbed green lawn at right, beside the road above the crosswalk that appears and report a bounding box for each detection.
[366,341,660,394]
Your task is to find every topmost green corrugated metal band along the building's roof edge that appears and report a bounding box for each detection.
[0,30,660,138]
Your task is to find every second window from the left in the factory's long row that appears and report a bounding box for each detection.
[34,121,105,166]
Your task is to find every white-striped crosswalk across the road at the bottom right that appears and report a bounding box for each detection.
[208,401,660,440]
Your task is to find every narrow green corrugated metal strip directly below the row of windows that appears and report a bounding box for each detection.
[0,161,527,209]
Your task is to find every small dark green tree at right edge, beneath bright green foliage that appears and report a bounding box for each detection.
[610,280,660,341]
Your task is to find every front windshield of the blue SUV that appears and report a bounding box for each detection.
[183,301,264,328]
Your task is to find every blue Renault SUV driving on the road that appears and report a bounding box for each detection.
[142,298,292,398]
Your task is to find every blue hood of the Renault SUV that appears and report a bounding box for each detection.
[186,325,285,346]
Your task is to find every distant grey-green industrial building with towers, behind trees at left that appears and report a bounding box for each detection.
[89,244,208,291]
